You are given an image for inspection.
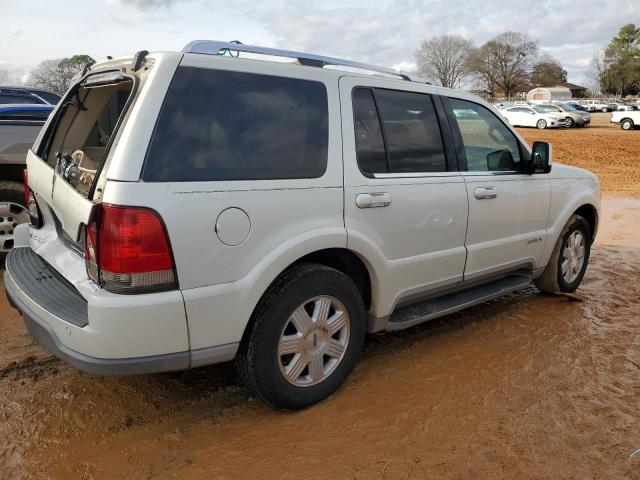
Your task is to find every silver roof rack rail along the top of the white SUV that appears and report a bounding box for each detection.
[182,40,428,83]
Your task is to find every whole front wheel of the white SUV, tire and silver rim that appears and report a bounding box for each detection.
[534,215,591,293]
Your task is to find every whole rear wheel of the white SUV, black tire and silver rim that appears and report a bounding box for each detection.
[235,263,365,410]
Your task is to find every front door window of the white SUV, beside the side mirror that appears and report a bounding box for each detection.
[449,98,528,172]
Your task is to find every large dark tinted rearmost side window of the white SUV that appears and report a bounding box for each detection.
[142,67,329,182]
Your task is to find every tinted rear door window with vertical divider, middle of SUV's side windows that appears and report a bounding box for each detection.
[353,87,447,176]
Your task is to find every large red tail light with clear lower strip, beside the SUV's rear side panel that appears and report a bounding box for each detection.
[85,204,177,293]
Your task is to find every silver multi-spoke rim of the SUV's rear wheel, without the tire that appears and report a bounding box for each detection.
[278,295,350,387]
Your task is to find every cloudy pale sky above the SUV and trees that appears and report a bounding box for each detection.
[0,0,640,86]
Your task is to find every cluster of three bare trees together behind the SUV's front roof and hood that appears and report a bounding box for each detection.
[416,32,567,96]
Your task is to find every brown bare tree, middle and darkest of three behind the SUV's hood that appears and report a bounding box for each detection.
[469,32,538,97]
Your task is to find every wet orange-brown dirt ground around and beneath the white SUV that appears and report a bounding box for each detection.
[0,115,640,480]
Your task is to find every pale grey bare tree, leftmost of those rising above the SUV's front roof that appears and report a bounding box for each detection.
[416,35,473,88]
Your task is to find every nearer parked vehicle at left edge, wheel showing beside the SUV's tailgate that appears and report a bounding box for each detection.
[0,103,53,264]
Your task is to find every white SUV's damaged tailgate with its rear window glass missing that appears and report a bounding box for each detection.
[27,70,137,248]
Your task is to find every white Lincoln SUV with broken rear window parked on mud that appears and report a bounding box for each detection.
[5,41,600,409]
